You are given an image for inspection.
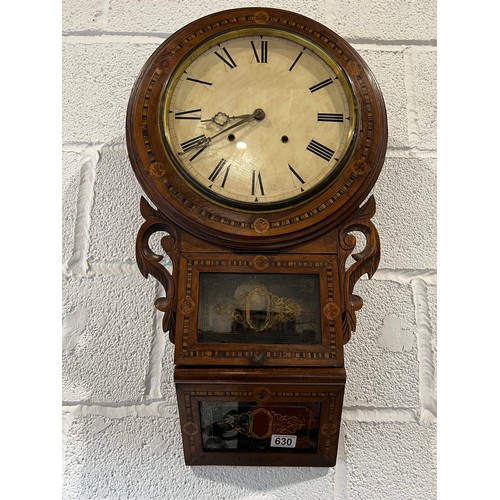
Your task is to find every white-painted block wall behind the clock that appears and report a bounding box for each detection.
[63,0,436,500]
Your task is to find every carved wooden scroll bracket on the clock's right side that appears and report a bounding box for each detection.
[339,195,380,344]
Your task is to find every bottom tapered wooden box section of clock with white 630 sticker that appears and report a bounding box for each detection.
[174,366,345,467]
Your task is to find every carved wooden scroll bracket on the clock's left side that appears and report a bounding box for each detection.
[135,197,180,342]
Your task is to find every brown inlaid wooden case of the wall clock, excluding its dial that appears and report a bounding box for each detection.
[127,8,387,466]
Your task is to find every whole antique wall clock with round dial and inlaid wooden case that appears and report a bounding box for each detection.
[127,8,387,466]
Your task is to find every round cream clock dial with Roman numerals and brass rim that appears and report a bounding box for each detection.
[161,28,356,210]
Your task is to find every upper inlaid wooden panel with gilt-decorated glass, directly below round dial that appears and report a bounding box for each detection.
[175,254,343,366]
